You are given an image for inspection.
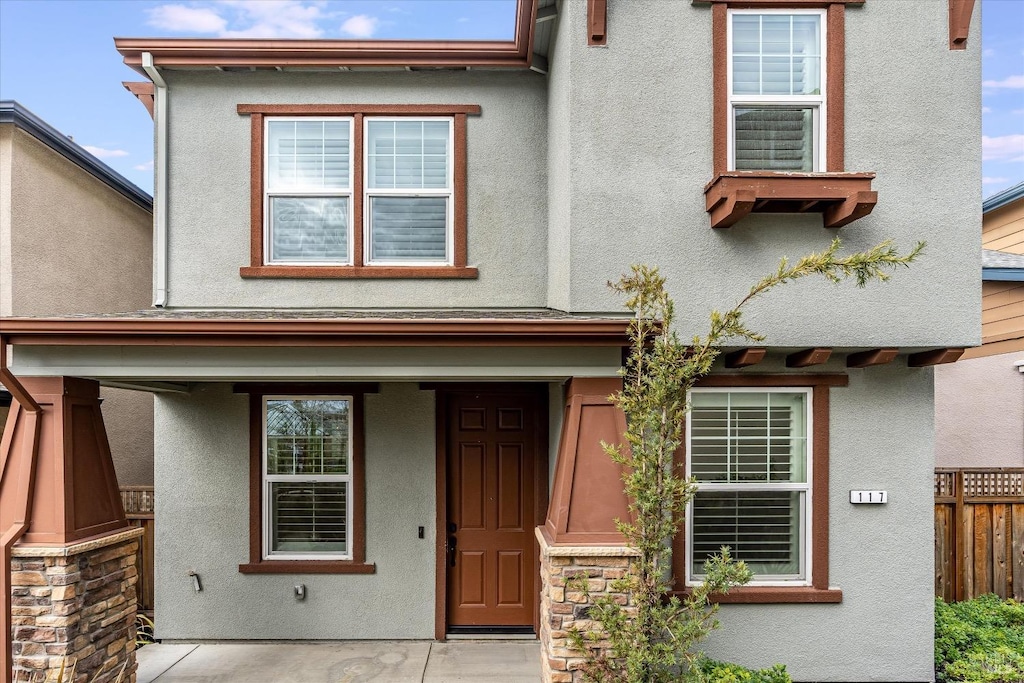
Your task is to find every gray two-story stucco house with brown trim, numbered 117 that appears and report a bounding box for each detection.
[3,0,981,681]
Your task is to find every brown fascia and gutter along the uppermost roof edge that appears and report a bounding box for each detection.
[114,0,537,76]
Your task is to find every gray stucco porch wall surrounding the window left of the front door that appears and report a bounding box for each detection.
[156,384,436,640]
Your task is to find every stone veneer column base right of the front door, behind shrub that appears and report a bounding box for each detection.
[537,527,637,683]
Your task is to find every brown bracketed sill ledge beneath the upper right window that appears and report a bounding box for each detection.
[705,171,879,228]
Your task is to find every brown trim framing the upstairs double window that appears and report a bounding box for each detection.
[238,104,480,279]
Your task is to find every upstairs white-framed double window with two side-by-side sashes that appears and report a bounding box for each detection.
[263,116,455,266]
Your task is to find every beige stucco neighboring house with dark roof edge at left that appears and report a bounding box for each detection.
[0,101,153,485]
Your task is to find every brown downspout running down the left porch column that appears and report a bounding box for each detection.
[0,336,43,683]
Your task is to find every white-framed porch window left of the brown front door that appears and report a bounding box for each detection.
[262,395,358,560]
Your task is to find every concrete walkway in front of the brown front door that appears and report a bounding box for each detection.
[137,640,541,683]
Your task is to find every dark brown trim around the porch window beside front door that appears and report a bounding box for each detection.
[234,383,378,573]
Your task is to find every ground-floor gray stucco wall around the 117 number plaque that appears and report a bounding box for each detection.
[703,366,934,681]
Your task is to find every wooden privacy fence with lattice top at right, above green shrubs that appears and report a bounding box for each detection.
[935,468,1024,602]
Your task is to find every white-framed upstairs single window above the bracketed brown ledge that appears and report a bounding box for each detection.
[726,9,826,172]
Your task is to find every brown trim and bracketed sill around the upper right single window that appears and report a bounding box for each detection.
[693,0,878,227]
